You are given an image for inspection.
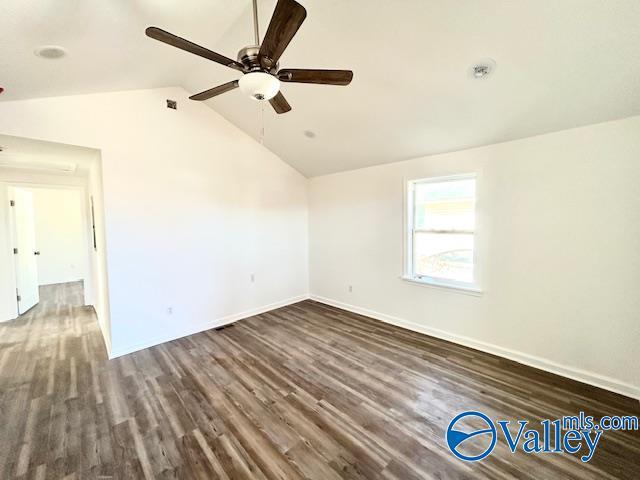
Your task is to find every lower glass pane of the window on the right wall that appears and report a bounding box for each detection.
[414,233,473,283]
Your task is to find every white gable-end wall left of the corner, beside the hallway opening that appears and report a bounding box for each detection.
[0,88,308,355]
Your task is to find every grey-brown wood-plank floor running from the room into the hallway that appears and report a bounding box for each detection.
[0,284,640,480]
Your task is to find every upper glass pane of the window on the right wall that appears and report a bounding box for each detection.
[414,179,476,231]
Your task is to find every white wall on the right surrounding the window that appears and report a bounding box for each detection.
[310,117,640,397]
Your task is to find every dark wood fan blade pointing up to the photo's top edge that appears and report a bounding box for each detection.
[260,0,307,68]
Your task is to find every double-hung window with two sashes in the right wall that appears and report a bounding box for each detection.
[405,175,479,291]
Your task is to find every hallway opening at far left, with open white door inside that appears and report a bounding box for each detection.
[0,134,111,352]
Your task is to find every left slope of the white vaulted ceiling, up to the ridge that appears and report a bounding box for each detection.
[0,0,248,100]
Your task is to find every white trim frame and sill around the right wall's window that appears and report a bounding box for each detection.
[400,173,482,295]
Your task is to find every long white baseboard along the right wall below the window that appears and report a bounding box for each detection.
[310,294,640,400]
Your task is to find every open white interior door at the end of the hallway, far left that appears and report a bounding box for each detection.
[9,187,40,315]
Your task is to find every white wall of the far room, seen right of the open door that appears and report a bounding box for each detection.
[29,188,88,285]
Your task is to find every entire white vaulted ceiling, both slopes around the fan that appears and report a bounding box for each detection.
[0,0,640,176]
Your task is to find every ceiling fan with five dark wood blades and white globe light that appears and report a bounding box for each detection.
[146,0,353,113]
